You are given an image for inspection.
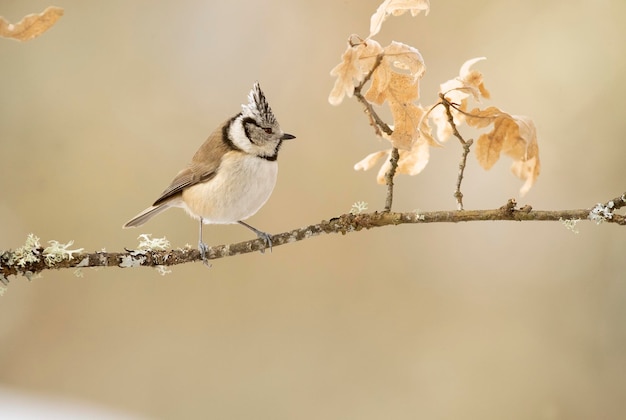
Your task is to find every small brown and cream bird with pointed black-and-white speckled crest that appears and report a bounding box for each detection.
[122,81,295,265]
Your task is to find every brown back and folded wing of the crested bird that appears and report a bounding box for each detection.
[153,121,232,206]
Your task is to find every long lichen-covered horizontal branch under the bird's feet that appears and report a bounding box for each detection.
[0,193,626,285]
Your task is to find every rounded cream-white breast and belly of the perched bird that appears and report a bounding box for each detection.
[183,151,278,223]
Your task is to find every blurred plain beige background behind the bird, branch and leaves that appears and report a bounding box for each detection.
[0,0,626,420]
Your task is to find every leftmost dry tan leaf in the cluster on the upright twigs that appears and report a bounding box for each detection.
[328,35,383,105]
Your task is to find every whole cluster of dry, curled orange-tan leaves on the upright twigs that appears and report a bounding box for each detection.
[328,0,540,195]
